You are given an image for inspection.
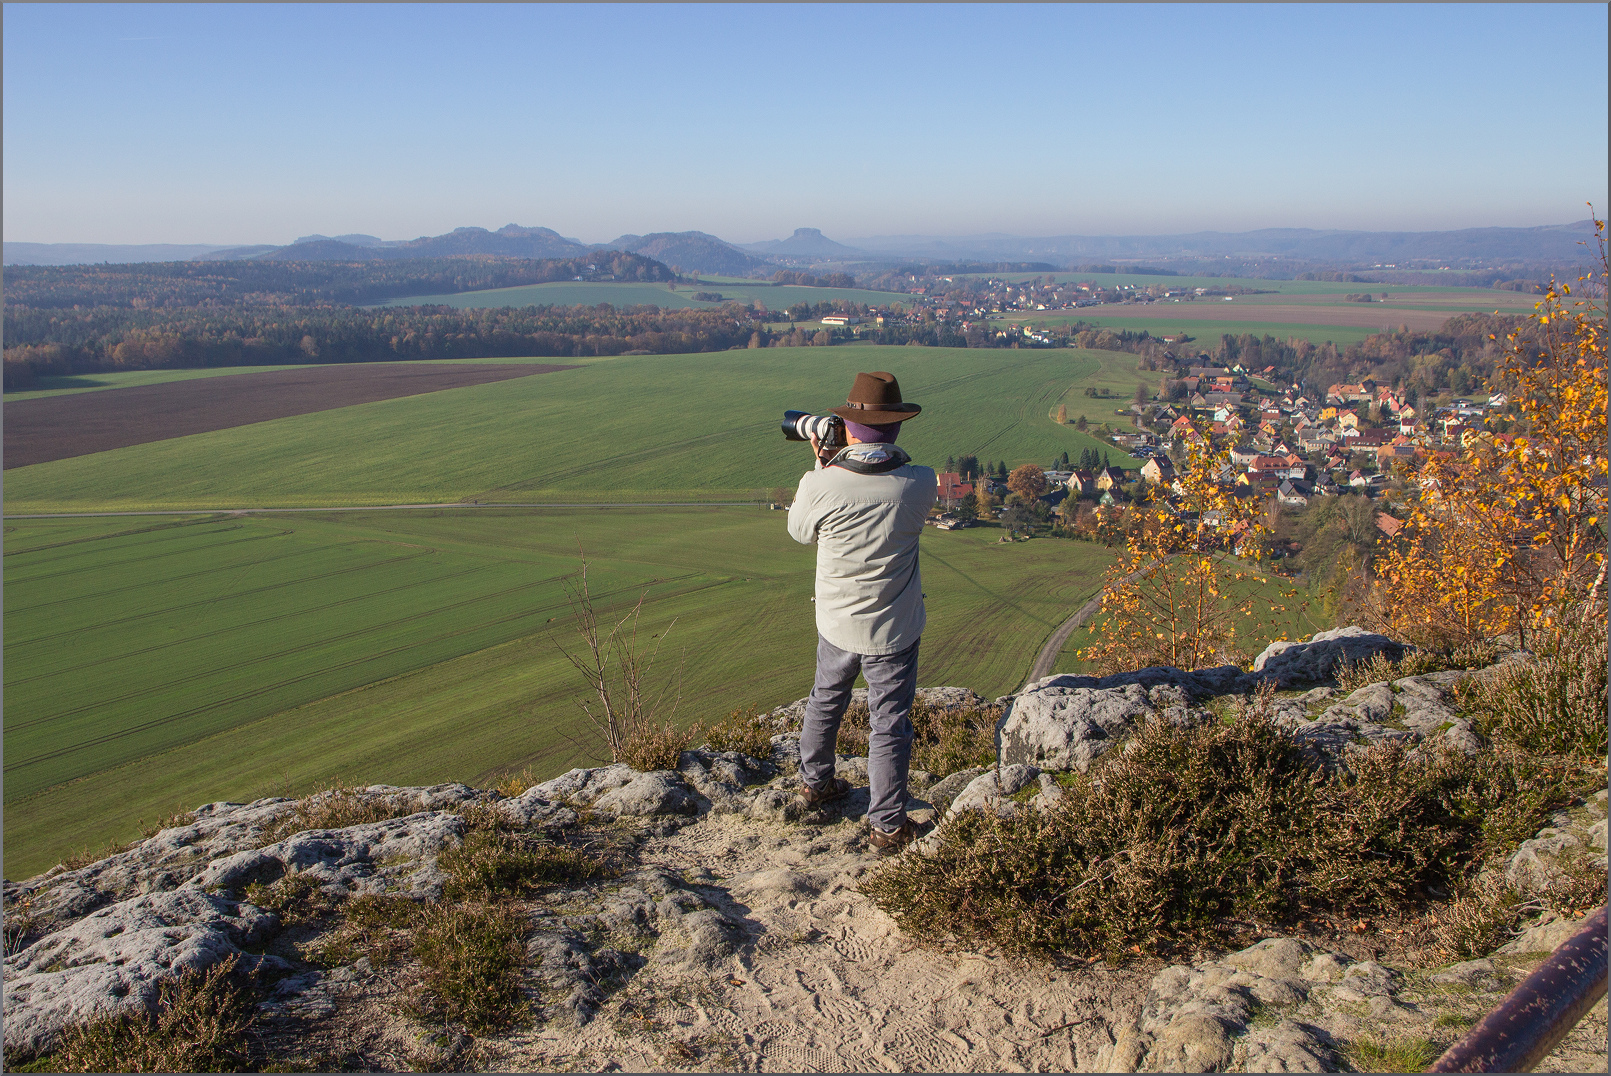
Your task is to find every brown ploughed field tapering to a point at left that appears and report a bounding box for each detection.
[5,362,575,470]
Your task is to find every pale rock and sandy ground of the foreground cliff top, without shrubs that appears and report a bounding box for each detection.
[5,650,1606,1071]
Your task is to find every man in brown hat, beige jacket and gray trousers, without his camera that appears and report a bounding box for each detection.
[789,372,938,854]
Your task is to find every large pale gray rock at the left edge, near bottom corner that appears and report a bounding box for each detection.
[5,889,288,1053]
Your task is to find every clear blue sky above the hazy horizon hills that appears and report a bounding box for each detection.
[3,3,1608,243]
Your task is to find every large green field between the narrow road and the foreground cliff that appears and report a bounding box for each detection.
[5,505,1108,878]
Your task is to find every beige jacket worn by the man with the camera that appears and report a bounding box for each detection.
[789,445,938,656]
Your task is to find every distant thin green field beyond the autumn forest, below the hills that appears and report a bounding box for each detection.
[368,280,912,311]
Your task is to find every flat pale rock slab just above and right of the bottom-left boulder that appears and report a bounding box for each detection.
[185,812,466,900]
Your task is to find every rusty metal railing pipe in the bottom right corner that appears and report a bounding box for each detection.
[1426,908,1606,1073]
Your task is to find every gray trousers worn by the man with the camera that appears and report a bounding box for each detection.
[801,635,921,833]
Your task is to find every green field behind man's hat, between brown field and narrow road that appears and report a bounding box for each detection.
[5,345,1157,515]
